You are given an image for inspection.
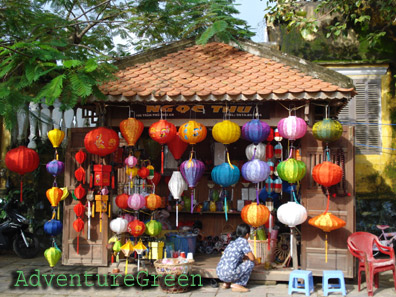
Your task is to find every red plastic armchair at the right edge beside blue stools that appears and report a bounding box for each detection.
[347,232,396,296]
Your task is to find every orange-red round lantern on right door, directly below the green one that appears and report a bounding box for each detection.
[312,161,343,188]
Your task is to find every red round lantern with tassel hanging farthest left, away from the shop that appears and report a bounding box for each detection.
[5,146,40,202]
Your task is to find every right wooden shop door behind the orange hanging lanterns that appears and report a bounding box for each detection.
[301,126,355,278]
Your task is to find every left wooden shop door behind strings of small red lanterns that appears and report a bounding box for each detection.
[62,128,109,266]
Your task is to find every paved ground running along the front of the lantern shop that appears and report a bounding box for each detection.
[0,252,396,297]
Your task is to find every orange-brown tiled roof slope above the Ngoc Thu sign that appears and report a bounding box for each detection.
[100,42,355,102]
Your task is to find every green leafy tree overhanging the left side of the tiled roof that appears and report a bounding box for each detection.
[0,0,253,127]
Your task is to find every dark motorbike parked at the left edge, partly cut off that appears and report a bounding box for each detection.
[0,199,39,259]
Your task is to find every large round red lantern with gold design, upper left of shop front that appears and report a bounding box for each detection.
[84,127,120,157]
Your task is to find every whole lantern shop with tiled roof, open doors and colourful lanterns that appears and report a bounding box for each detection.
[62,41,355,280]
